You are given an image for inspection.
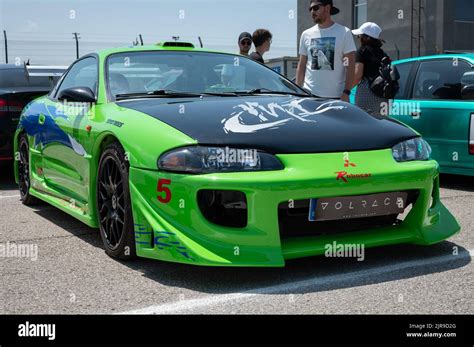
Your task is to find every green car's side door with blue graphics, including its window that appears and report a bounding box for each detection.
[42,56,98,206]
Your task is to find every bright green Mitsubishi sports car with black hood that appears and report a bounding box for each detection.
[15,42,460,267]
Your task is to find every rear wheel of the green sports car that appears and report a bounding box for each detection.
[18,134,40,206]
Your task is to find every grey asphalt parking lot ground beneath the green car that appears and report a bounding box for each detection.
[0,163,474,314]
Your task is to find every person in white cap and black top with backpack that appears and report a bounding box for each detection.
[352,22,388,116]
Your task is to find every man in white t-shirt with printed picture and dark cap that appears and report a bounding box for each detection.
[296,0,356,102]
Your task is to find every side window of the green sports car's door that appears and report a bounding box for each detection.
[56,57,98,95]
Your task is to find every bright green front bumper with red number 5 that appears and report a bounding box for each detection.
[130,150,460,267]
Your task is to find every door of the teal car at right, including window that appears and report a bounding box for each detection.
[392,58,473,172]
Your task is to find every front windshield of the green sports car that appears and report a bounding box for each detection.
[107,51,306,99]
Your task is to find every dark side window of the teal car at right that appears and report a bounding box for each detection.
[413,60,472,100]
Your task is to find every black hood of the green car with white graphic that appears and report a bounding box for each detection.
[117,96,418,154]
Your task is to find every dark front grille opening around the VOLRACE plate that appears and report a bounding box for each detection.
[278,190,420,239]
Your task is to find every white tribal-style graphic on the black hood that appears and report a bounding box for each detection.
[222,99,346,134]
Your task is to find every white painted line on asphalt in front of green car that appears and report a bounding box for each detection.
[123,250,474,314]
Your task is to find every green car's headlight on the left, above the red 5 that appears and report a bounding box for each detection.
[158,146,283,174]
